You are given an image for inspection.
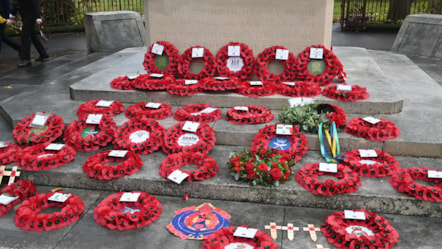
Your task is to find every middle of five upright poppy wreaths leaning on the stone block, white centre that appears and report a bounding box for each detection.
[215,42,255,80]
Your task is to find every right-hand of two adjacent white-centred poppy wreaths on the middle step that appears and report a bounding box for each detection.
[162,121,216,154]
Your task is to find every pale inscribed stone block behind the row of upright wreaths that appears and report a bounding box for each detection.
[144,0,333,56]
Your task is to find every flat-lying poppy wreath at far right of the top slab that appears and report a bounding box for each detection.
[322,84,370,102]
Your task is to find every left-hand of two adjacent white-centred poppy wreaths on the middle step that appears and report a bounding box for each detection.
[114,118,165,155]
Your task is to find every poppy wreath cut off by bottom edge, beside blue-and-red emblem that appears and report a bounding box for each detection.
[201,225,278,249]
